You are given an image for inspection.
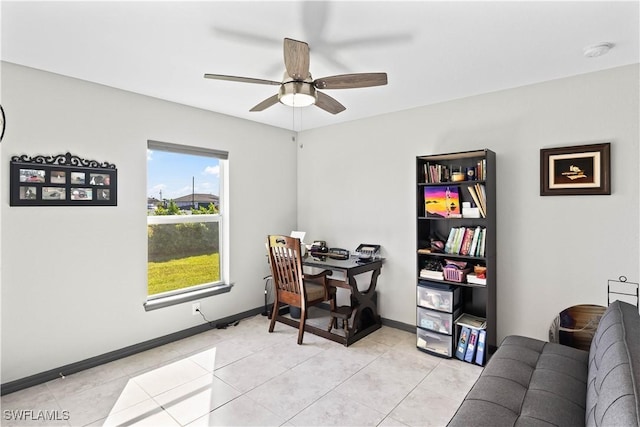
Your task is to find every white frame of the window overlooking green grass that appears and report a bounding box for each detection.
[143,140,233,311]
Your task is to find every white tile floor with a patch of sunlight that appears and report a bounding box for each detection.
[2,310,482,427]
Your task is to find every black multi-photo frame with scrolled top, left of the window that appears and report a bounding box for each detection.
[10,153,118,206]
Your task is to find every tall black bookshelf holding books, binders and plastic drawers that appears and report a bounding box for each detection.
[416,149,497,364]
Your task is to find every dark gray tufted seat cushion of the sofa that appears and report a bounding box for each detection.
[449,336,588,426]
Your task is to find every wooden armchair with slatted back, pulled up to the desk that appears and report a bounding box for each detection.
[267,235,335,344]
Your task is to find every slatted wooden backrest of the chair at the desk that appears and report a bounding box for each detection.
[268,235,305,307]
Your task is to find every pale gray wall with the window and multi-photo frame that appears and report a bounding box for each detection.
[0,63,297,383]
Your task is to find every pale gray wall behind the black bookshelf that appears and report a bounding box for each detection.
[298,65,640,340]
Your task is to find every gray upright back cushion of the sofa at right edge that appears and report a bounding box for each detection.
[586,301,640,426]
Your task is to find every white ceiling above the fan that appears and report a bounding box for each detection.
[0,0,640,130]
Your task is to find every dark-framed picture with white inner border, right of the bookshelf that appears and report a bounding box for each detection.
[540,142,611,196]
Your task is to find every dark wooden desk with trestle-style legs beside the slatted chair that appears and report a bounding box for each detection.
[292,256,384,346]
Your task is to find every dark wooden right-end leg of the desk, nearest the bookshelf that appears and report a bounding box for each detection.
[347,268,382,345]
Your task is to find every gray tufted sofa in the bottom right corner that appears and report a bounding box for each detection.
[449,301,640,427]
